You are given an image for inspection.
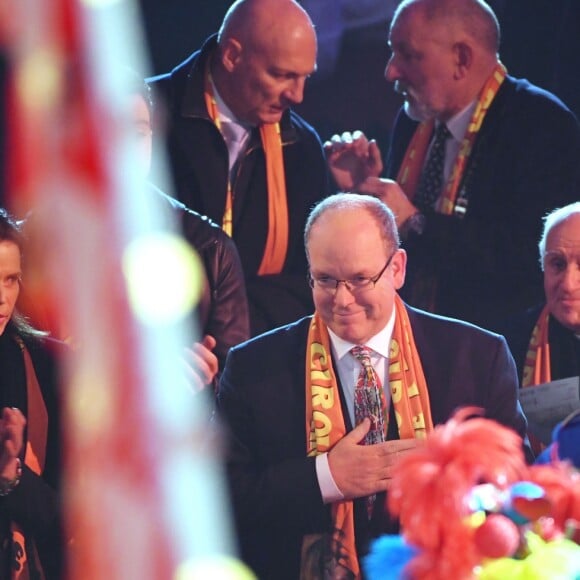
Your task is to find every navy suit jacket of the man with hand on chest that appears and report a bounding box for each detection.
[217,308,526,579]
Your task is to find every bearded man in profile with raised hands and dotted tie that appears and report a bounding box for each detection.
[327,0,580,328]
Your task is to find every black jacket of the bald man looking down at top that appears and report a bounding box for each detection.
[149,36,329,334]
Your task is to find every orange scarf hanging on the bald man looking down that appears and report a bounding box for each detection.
[204,65,288,276]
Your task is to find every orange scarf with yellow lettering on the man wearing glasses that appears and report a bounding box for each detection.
[306,296,433,578]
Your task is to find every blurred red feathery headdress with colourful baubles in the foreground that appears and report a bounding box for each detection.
[365,408,580,580]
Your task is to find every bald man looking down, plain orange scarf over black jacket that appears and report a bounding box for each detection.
[150,0,328,334]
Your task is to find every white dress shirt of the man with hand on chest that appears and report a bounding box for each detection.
[316,308,395,503]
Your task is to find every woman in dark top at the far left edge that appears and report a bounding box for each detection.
[0,209,63,580]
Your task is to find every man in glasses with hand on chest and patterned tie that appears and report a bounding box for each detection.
[218,194,526,579]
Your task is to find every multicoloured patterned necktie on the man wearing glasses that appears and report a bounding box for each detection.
[351,346,387,445]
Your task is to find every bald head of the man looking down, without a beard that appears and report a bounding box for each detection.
[212,0,317,125]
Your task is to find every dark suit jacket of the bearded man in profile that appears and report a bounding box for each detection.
[387,76,580,330]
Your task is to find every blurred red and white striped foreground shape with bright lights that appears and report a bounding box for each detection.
[3,0,254,580]
